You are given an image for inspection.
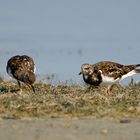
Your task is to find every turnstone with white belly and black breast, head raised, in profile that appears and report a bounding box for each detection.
[79,61,140,94]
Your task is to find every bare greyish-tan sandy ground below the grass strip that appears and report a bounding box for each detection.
[0,119,140,140]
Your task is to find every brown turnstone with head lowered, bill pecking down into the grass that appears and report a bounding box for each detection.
[6,55,36,92]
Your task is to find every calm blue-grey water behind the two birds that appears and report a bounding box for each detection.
[0,0,140,83]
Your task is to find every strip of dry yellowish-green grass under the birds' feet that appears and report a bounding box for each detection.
[0,81,140,119]
